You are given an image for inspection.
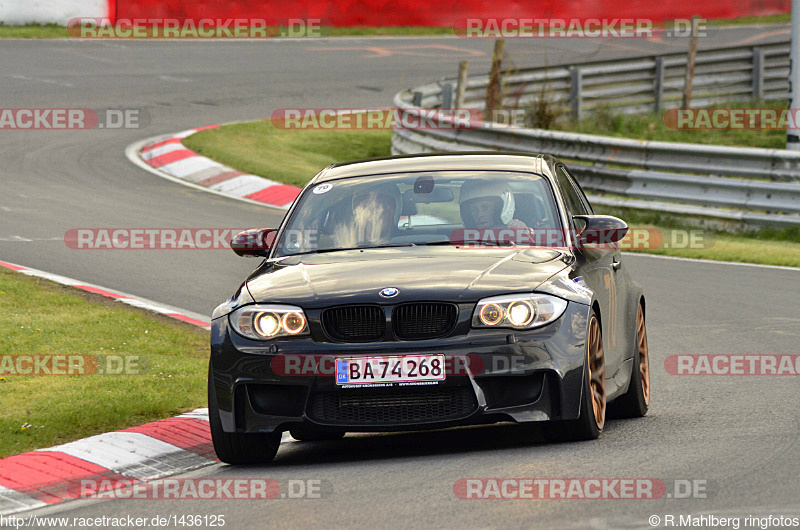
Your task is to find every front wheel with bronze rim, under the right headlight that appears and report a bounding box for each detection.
[542,313,605,442]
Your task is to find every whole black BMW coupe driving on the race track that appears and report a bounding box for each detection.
[208,153,650,464]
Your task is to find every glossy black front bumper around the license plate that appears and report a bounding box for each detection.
[210,302,590,433]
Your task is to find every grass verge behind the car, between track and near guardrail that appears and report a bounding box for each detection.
[184,120,800,267]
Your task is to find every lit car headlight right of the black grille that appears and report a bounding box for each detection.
[472,294,567,329]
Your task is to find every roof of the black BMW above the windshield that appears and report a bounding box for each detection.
[309,151,558,184]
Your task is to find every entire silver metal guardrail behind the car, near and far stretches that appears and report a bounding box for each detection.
[392,43,800,228]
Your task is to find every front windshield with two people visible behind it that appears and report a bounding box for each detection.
[275,171,561,257]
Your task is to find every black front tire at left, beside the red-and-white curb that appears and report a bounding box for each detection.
[208,366,281,465]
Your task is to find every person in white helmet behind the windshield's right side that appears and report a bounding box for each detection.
[459,180,528,229]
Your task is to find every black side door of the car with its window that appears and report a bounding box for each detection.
[556,164,625,379]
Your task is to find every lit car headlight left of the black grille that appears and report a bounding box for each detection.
[230,305,308,340]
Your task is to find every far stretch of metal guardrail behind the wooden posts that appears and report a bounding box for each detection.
[440,42,789,118]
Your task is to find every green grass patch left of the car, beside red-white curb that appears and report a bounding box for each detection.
[0,269,209,457]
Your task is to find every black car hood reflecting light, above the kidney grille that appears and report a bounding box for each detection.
[247,247,572,308]
